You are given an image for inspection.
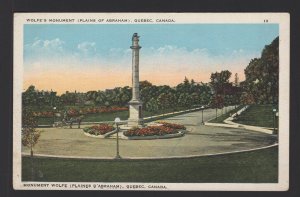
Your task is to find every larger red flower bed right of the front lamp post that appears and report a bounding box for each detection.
[123,122,185,137]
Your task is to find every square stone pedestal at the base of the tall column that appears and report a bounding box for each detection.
[128,100,143,127]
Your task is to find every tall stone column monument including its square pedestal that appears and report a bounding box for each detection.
[128,33,143,127]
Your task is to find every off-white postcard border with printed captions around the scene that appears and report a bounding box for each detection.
[13,13,290,191]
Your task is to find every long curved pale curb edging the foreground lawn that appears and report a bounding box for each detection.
[22,143,278,160]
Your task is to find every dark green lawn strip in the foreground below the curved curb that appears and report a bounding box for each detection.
[22,147,278,183]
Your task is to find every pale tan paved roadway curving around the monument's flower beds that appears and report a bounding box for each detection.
[22,109,277,158]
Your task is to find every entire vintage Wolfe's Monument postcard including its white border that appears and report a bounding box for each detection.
[13,13,290,191]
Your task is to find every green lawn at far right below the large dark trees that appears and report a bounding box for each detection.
[234,105,278,128]
